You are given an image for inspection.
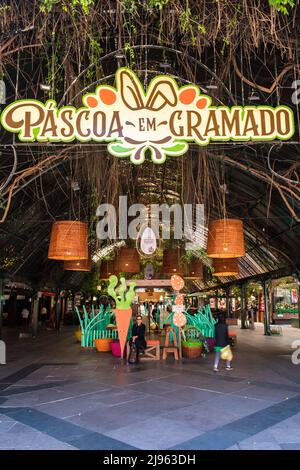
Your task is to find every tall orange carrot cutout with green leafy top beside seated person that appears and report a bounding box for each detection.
[107,276,136,357]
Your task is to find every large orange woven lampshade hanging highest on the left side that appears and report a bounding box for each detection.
[48,220,89,260]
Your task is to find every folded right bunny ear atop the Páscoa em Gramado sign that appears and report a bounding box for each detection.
[146,79,177,111]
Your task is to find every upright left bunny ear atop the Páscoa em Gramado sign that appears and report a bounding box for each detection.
[119,70,144,111]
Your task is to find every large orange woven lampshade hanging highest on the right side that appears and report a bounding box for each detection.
[207,219,245,258]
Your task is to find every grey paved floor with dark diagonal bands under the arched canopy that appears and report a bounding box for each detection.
[0,326,300,450]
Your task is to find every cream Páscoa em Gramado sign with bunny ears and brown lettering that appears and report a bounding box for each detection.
[1,67,295,164]
